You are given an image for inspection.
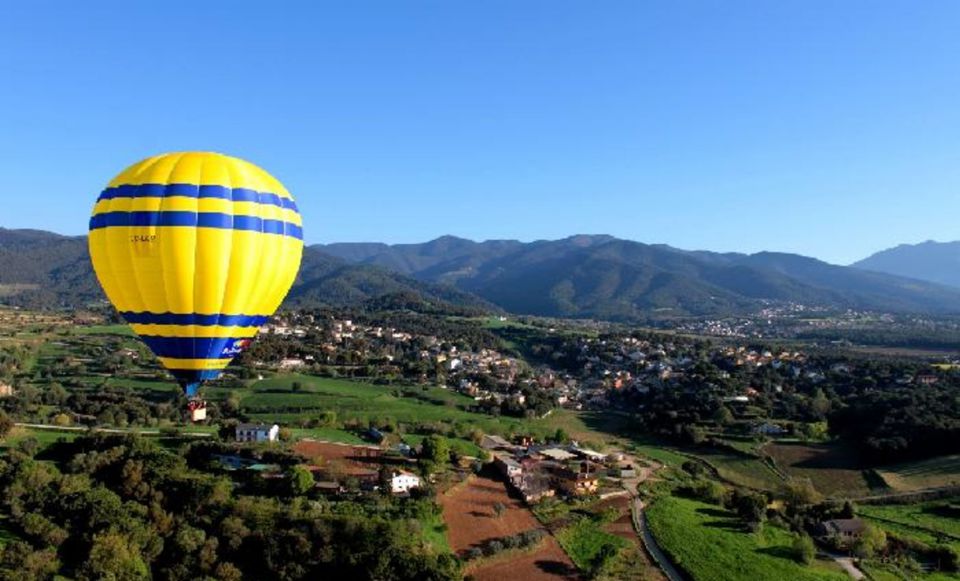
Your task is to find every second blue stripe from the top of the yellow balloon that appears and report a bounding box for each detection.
[90,212,303,240]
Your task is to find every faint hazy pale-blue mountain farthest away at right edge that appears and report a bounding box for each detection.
[851,240,960,288]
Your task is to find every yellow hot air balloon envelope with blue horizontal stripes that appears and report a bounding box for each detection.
[89,152,303,414]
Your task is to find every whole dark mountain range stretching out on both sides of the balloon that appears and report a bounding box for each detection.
[0,228,960,321]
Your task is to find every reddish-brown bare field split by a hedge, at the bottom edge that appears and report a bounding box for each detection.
[440,476,579,581]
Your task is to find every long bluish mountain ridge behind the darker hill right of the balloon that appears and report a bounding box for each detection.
[317,235,960,320]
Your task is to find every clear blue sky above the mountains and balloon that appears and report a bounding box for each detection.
[0,0,960,263]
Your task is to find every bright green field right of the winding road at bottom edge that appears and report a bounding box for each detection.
[646,496,848,581]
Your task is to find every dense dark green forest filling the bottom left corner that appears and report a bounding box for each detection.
[0,435,460,581]
